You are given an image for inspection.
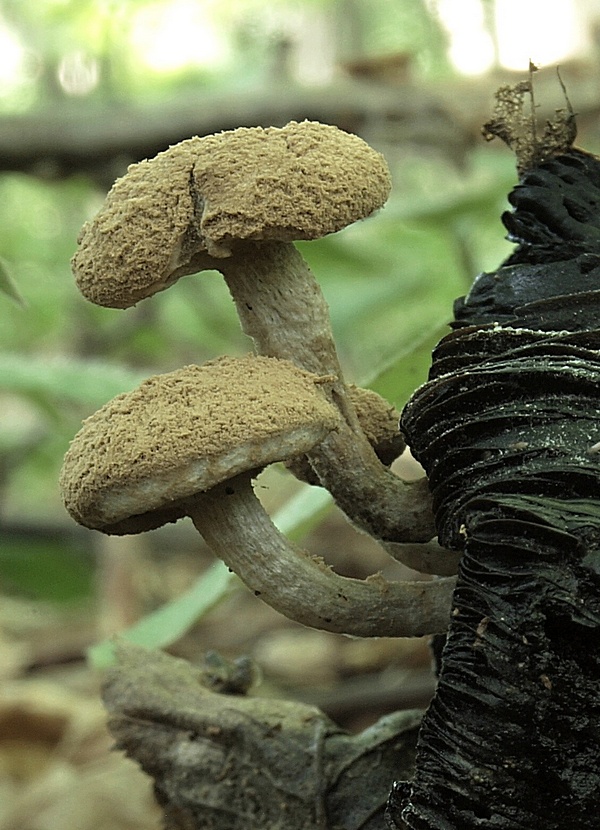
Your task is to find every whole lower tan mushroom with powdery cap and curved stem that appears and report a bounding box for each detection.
[60,355,454,636]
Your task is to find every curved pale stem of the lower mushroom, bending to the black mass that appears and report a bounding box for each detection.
[186,473,455,637]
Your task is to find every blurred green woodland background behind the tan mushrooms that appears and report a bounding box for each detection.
[0,0,597,616]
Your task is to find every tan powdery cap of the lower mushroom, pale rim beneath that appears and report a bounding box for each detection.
[60,355,339,534]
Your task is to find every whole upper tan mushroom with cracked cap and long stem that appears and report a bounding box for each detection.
[73,121,445,572]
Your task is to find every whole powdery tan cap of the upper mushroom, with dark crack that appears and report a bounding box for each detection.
[72,121,391,308]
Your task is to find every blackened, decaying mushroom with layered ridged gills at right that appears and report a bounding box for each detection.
[389,84,600,830]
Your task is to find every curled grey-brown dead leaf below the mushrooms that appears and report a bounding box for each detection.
[104,645,420,830]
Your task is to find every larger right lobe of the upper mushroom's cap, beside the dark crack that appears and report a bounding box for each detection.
[194,121,391,256]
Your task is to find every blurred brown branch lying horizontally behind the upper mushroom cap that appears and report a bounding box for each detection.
[0,63,599,187]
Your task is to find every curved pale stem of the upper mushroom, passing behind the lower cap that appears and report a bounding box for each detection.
[214,242,435,548]
